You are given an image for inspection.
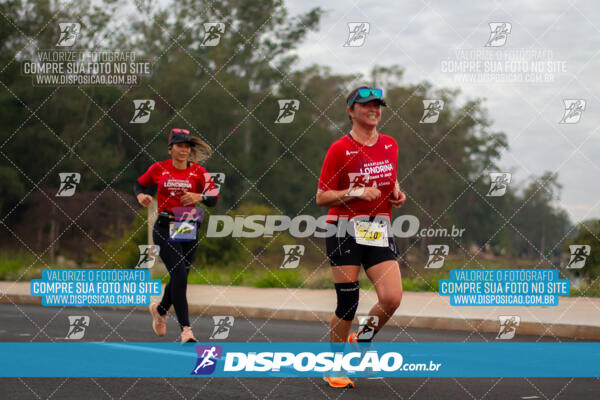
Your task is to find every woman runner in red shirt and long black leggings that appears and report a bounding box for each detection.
[134,129,217,342]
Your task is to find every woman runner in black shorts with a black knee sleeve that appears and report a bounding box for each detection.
[316,86,406,387]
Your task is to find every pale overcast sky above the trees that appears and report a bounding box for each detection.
[285,0,600,222]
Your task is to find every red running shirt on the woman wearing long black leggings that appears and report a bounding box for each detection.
[138,160,214,212]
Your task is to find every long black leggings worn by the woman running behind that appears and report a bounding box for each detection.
[152,221,198,329]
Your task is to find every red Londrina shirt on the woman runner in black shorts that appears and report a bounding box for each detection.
[318,133,398,221]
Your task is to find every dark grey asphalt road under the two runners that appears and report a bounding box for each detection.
[0,304,600,400]
